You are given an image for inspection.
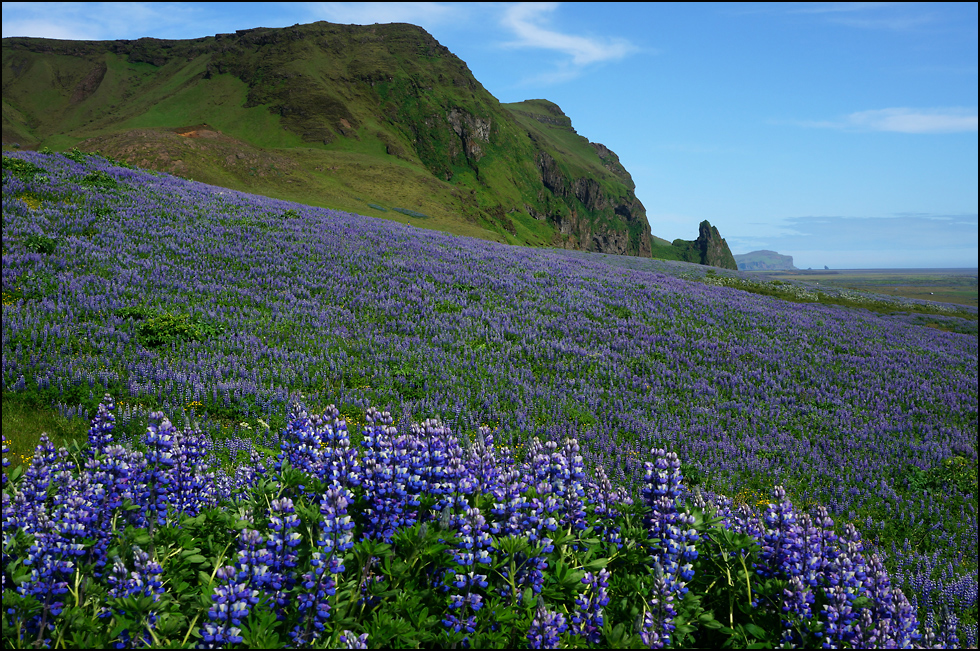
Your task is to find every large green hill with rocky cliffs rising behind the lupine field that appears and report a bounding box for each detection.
[2,22,728,259]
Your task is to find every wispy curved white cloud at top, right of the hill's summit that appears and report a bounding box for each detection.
[500,2,638,68]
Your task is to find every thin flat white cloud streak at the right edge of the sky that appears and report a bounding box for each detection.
[797,107,977,133]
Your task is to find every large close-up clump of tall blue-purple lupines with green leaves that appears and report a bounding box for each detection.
[3,396,940,649]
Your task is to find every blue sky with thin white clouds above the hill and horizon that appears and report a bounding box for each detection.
[3,2,978,269]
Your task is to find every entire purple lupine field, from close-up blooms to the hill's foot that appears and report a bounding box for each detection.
[2,153,978,648]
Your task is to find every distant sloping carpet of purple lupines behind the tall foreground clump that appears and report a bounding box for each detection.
[2,153,978,644]
